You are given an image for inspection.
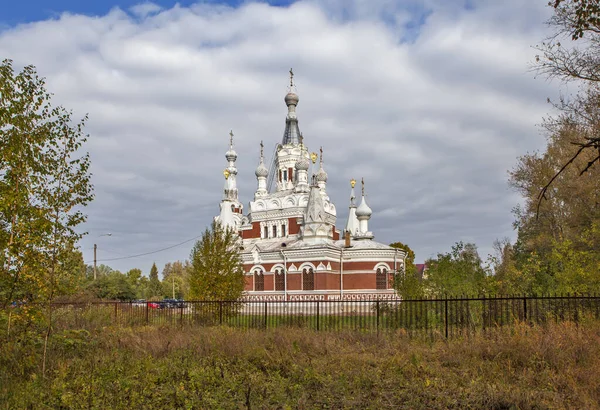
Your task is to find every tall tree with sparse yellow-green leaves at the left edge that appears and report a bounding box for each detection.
[0,60,92,307]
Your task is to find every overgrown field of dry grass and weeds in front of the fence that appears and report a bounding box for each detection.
[0,323,600,409]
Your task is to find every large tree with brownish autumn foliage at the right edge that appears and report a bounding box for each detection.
[509,112,600,257]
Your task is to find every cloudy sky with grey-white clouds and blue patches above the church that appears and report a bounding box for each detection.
[0,0,558,274]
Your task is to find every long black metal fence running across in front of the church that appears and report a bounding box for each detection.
[45,295,600,338]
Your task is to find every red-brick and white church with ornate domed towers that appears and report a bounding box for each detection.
[215,70,406,301]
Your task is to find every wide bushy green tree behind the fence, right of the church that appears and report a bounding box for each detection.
[425,242,487,296]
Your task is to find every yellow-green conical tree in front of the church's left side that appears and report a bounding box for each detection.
[189,221,244,300]
